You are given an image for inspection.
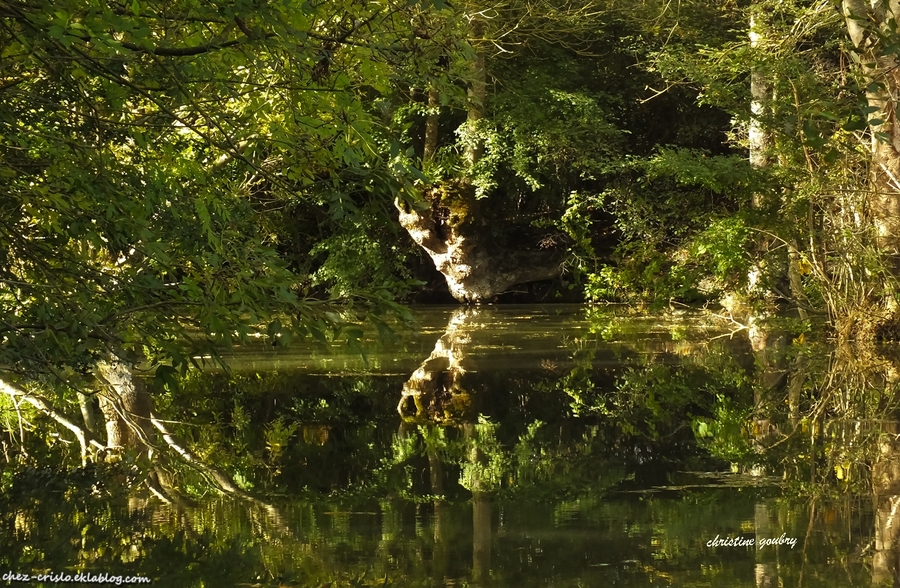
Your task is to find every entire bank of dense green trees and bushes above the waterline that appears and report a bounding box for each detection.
[0,0,900,379]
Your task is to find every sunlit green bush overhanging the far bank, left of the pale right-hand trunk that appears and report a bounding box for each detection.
[585,148,762,300]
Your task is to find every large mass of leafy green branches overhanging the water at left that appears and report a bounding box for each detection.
[0,0,450,379]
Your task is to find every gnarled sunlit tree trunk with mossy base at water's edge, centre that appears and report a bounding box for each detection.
[395,16,562,303]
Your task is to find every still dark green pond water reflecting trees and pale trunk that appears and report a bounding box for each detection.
[0,305,900,588]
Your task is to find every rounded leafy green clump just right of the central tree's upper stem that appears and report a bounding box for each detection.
[485,46,627,193]
